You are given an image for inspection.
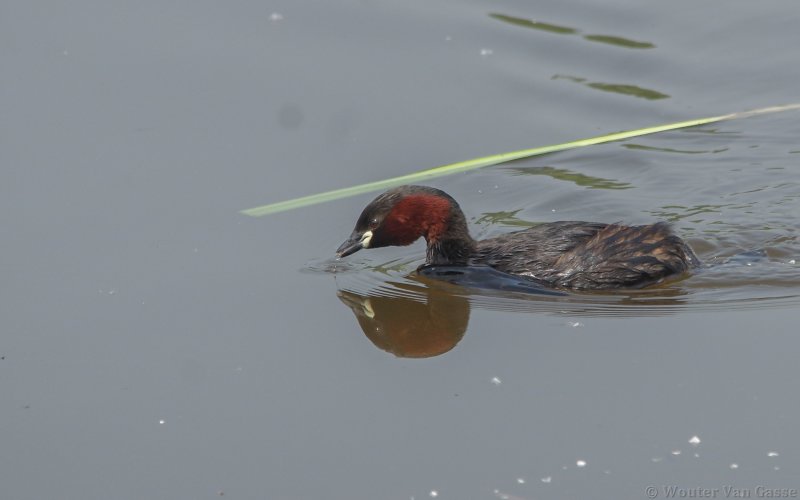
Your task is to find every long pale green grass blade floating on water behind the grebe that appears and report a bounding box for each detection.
[241,103,800,217]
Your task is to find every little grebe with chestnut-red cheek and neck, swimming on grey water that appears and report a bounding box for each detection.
[337,186,699,290]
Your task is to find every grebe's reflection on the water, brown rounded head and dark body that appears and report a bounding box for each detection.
[337,267,687,358]
